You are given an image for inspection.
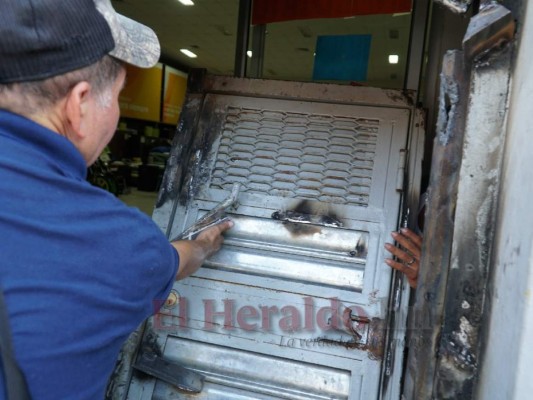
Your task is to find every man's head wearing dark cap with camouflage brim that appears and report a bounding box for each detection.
[0,0,160,164]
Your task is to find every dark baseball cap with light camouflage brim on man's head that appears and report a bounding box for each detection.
[0,0,160,84]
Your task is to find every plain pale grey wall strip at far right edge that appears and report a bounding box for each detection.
[477,2,533,399]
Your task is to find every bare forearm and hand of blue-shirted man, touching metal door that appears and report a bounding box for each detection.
[171,221,233,280]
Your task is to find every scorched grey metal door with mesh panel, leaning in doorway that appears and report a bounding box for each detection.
[118,73,422,399]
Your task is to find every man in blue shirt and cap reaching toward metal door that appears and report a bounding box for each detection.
[0,0,232,400]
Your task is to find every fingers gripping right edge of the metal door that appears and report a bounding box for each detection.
[385,228,422,288]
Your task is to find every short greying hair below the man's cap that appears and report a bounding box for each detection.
[0,55,123,117]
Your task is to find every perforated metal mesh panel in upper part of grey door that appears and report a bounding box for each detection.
[211,107,380,206]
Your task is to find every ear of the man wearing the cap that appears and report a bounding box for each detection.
[65,81,91,139]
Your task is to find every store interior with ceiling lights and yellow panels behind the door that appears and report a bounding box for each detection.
[103,0,424,214]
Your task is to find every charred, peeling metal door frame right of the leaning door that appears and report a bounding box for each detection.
[404,2,514,400]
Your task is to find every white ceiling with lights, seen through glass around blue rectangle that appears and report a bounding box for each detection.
[113,0,411,88]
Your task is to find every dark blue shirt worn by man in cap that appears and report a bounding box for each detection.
[0,110,178,400]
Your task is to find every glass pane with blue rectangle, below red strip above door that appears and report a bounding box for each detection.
[249,13,411,89]
